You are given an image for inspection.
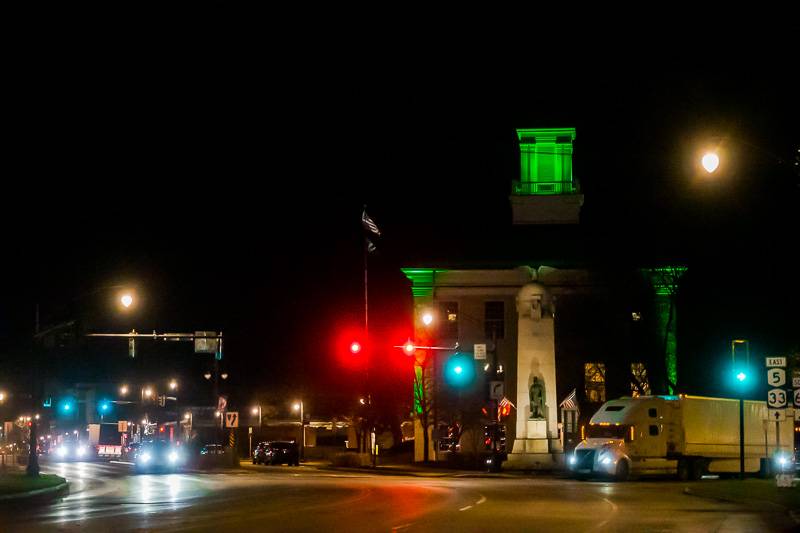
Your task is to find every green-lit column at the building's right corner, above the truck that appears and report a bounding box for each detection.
[643,266,686,394]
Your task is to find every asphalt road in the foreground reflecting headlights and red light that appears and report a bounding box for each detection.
[0,463,798,533]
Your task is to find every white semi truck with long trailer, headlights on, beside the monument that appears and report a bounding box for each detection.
[567,394,794,480]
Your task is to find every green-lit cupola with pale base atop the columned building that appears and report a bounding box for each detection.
[511,128,583,224]
